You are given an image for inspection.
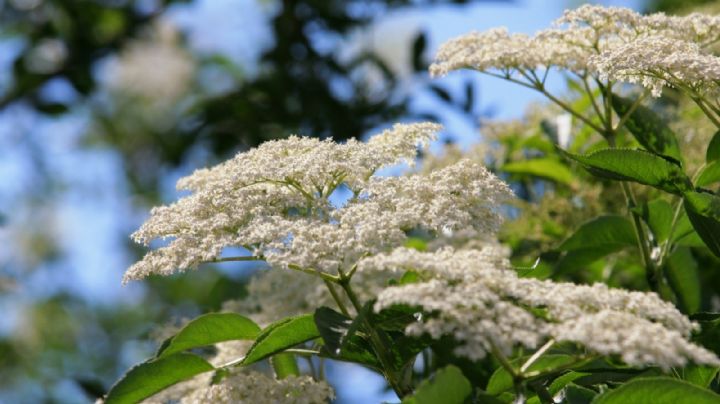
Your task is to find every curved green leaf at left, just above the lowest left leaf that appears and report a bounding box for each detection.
[157,313,260,357]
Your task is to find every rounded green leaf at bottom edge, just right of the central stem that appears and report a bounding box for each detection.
[402,365,472,404]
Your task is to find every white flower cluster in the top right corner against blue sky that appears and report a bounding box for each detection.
[430,5,720,96]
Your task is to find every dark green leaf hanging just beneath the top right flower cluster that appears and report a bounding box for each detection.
[612,95,682,161]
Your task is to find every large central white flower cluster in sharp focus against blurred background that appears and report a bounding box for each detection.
[124,123,511,282]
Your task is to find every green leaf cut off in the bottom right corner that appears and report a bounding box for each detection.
[593,377,720,404]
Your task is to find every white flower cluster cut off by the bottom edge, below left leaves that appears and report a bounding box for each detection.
[180,372,335,404]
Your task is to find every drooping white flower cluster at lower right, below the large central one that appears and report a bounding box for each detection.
[358,245,720,370]
